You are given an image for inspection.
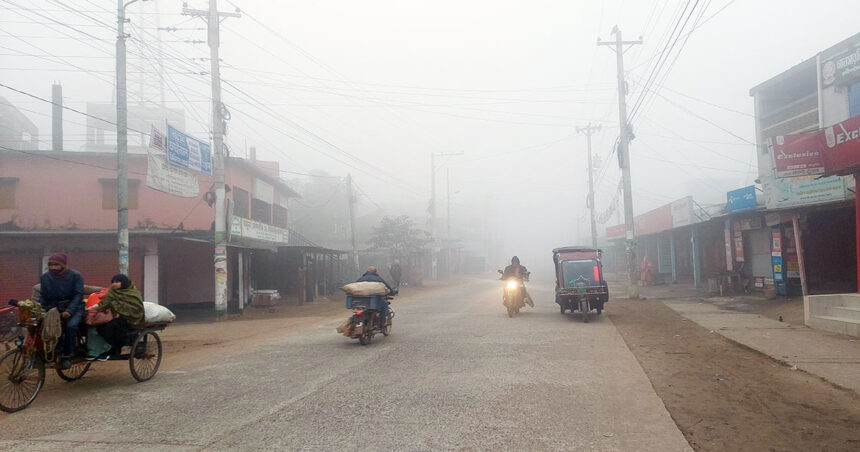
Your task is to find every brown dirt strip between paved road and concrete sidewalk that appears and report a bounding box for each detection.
[606,300,860,451]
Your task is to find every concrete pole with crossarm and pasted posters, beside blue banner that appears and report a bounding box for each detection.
[182,0,242,313]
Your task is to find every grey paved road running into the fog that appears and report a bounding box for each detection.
[0,281,689,451]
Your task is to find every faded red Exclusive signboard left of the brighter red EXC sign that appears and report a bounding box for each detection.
[769,131,824,177]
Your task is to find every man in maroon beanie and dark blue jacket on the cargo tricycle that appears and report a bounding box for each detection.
[39,253,84,369]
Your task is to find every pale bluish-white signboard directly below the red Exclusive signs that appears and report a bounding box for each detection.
[762,176,846,209]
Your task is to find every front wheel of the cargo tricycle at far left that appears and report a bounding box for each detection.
[0,348,45,413]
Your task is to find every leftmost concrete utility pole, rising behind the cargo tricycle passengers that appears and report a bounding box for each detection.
[116,0,143,275]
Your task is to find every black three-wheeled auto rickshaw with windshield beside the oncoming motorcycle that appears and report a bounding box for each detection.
[552,246,609,322]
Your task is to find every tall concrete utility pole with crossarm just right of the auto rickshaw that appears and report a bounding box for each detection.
[597,25,642,298]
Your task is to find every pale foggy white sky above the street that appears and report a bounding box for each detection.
[0,0,857,272]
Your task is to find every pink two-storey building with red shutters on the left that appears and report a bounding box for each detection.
[0,148,300,308]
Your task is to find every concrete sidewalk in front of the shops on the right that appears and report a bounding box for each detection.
[642,286,860,393]
